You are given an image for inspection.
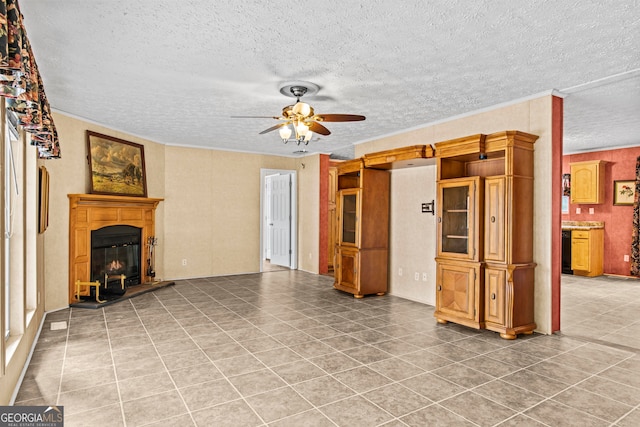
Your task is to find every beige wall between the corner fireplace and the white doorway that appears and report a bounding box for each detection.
[161,146,298,279]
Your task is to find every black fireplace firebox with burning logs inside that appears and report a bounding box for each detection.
[91,225,142,293]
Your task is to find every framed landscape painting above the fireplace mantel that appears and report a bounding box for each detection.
[87,131,147,197]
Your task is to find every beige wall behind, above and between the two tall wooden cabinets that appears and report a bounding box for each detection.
[355,95,552,333]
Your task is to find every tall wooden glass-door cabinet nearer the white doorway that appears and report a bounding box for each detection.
[334,159,390,298]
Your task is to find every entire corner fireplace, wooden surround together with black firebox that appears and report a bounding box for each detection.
[68,194,163,304]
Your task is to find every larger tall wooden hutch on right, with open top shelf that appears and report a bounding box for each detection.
[434,131,538,339]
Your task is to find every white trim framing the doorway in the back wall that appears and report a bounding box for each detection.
[259,169,298,272]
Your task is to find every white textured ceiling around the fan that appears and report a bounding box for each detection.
[20,0,640,157]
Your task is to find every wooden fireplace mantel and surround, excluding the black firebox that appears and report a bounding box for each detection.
[68,194,164,304]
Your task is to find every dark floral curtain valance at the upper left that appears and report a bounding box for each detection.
[0,0,60,159]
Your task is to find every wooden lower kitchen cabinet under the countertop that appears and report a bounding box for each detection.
[571,228,604,277]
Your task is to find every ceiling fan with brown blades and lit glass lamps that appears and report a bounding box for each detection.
[232,82,365,145]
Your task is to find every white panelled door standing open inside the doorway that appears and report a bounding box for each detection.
[270,175,291,267]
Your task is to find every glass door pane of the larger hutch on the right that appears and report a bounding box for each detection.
[442,185,469,254]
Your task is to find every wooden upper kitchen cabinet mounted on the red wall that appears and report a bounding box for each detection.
[570,160,606,204]
